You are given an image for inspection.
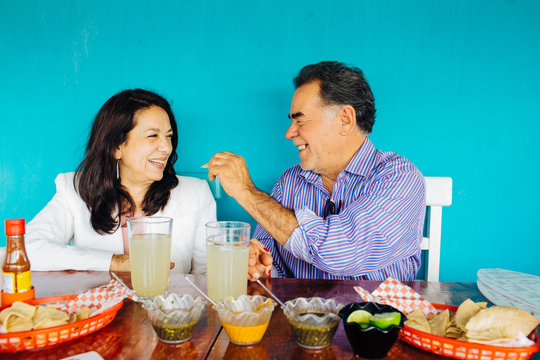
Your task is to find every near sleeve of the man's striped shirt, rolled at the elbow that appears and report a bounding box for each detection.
[284,166,425,276]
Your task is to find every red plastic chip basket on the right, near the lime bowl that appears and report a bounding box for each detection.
[399,304,540,360]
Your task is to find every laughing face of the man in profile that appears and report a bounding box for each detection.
[285,81,340,175]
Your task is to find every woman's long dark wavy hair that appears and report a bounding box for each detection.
[73,89,178,234]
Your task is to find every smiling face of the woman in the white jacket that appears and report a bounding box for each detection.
[115,105,173,188]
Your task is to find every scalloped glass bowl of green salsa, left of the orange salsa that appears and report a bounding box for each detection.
[143,293,206,344]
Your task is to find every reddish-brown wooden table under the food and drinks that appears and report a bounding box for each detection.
[0,271,540,360]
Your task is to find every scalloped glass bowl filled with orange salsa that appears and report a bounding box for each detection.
[214,295,276,345]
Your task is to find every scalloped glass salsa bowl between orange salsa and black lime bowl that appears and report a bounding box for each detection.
[283,297,343,349]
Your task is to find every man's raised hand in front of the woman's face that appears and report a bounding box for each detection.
[208,151,255,200]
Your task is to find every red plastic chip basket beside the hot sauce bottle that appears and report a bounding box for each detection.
[0,295,123,352]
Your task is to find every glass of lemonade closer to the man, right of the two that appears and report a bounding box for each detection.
[206,221,251,301]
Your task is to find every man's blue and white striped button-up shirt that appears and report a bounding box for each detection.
[253,139,425,281]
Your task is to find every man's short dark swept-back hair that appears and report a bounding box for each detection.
[293,61,376,134]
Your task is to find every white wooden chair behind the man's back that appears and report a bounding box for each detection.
[420,176,452,281]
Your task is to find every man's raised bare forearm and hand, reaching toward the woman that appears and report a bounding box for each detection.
[208,151,298,245]
